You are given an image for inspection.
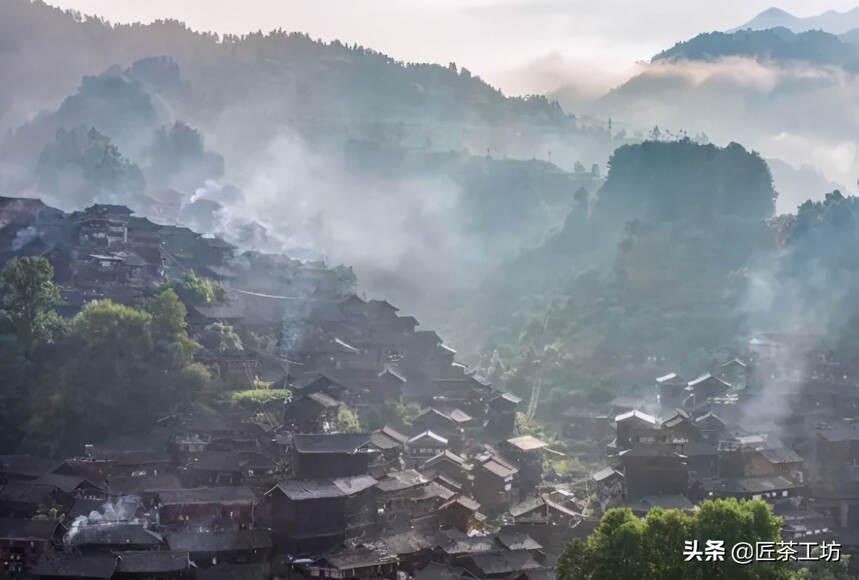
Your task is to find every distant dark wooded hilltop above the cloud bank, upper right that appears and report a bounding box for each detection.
[652,27,859,65]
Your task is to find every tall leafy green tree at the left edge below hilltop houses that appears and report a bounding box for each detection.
[0,256,62,353]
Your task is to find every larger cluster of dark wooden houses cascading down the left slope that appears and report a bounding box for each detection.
[0,198,572,580]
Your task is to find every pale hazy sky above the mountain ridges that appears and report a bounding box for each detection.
[49,0,859,93]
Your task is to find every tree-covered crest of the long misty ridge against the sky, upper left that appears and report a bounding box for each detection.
[0,0,566,127]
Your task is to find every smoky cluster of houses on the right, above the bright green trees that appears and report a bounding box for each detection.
[565,333,859,572]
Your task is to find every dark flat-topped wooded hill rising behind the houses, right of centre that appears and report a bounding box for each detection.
[474,140,788,420]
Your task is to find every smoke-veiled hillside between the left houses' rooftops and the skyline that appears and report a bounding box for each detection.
[0,0,622,336]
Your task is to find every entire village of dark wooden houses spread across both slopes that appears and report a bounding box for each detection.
[5,198,859,580]
